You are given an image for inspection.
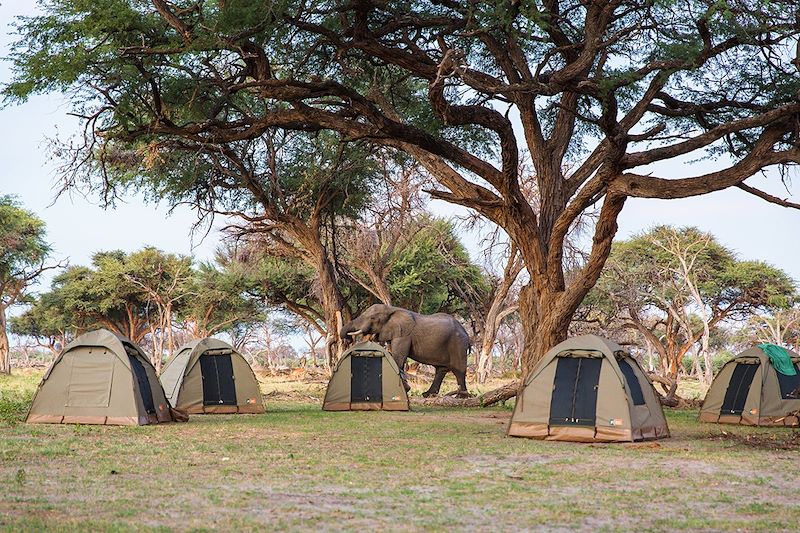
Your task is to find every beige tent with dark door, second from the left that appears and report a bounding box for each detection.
[161,338,264,414]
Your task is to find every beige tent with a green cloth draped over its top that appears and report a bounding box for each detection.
[700,347,800,427]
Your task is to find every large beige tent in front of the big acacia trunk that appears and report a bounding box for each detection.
[508,335,669,442]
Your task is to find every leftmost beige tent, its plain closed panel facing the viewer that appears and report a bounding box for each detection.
[27,329,172,425]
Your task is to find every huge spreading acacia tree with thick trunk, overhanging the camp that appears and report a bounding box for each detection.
[4,0,800,372]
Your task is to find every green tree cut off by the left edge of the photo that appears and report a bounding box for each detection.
[0,196,54,374]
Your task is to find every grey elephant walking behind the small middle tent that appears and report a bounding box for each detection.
[339,304,470,397]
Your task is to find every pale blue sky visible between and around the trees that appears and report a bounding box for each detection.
[0,0,800,298]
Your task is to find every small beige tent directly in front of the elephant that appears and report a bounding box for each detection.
[322,342,408,411]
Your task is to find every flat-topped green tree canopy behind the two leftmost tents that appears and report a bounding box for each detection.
[12,247,262,340]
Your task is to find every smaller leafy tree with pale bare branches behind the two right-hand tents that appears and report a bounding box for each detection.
[586,226,795,395]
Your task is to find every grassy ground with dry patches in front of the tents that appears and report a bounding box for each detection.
[0,368,800,531]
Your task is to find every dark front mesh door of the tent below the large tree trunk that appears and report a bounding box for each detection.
[550,357,603,426]
